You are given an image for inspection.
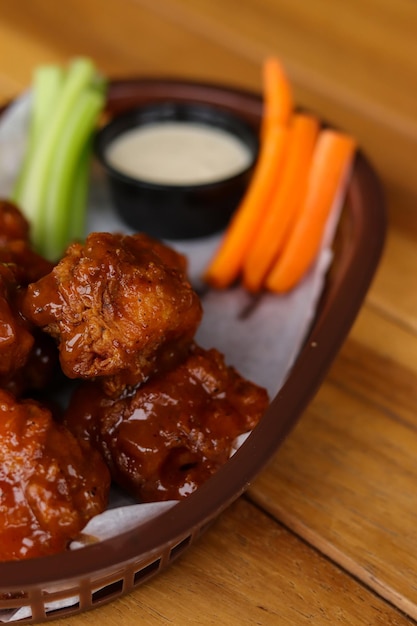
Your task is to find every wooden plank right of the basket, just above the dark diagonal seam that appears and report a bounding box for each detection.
[250,309,417,618]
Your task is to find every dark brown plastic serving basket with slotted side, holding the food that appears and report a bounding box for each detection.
[0,79,386,623]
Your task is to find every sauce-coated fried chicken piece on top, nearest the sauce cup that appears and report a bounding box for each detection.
[23,233,201,394]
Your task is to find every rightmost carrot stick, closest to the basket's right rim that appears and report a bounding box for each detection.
[266,130,356,293]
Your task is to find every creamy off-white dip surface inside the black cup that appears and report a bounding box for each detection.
[106,122,252,185]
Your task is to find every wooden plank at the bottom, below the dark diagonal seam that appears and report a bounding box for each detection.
[50,499,411,626]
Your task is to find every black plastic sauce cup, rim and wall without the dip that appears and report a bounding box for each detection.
[95,102,258,240]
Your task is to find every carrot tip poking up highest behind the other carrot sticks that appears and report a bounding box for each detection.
[261,57,293,138]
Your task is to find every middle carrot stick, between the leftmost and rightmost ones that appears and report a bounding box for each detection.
[243,114,319,292]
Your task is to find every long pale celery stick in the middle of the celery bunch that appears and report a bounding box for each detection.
[15,58,95,252]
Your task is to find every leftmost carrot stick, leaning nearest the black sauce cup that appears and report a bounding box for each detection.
[204,125,288,289]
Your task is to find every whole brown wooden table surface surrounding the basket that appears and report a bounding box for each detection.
[0,0,417,626]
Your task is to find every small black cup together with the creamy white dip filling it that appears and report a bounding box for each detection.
[94,101,259,240]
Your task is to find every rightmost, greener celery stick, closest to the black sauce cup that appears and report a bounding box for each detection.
[38,89,104,260]
